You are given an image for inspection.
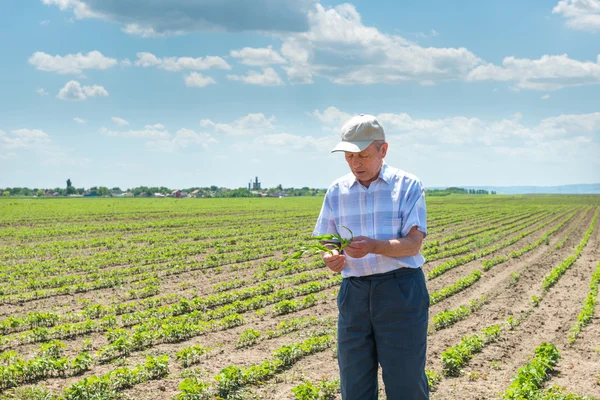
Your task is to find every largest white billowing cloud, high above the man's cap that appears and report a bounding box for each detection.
[281,4,482,84]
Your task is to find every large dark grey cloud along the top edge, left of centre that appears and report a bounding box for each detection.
[42,0,316,37]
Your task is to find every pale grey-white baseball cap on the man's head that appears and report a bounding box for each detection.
[331,114,385,153]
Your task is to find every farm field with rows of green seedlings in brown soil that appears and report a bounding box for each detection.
[0,195,600,400]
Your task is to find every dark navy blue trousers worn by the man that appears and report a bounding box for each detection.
[337,268,429,400]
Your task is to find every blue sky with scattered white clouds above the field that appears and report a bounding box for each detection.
[0,0,600,188]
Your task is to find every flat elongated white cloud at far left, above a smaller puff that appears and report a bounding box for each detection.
[29,51,117,74]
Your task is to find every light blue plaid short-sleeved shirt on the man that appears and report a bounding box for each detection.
[313,162,427,278]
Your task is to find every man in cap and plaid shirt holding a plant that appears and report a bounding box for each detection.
[313,114,429,400]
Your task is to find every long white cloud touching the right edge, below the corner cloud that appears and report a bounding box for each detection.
[467,54,600,91]
